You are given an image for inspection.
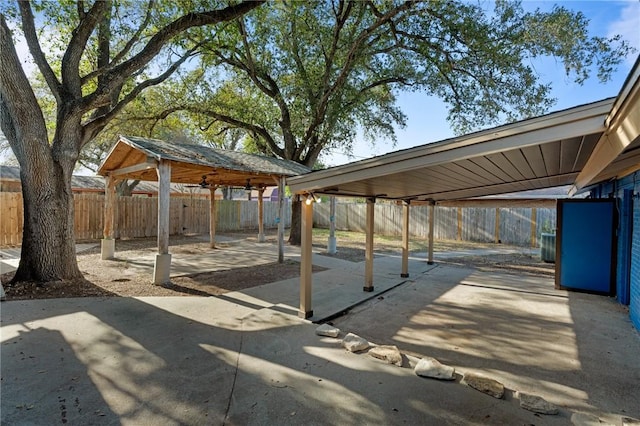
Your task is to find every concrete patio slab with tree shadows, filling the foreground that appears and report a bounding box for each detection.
[0,238,640,425]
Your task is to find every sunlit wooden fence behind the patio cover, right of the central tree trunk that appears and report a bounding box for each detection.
[313,203,556,246]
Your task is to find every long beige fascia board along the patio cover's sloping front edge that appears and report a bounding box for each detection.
[288,99,613,193]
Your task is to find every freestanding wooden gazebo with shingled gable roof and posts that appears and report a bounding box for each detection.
[98,136,311,284]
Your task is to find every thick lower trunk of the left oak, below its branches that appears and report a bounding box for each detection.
[11,152,82,283]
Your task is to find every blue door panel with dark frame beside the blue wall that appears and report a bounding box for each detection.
[556,199,615,295]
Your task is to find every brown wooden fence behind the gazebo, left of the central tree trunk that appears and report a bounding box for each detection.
[0,192,291,246]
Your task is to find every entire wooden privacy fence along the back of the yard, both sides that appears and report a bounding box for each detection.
[0,192,556,246]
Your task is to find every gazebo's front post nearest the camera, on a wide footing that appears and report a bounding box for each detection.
[153,161,171,284]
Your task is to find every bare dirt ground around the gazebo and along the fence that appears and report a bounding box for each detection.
[0,230,554,300]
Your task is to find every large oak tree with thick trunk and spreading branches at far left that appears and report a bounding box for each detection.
[0,0,260,282]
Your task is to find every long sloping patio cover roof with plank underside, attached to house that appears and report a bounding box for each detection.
[288,60,640,201]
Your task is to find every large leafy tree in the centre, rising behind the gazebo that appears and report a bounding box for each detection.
[148,0,630,244]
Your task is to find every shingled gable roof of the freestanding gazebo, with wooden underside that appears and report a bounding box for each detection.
[98,136,310,186]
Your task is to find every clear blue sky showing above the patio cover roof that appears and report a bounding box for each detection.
[322,0,640,166]
